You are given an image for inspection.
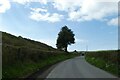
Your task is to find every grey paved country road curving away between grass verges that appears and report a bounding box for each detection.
[47,56,117,78]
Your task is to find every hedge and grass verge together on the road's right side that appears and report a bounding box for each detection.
[85,50,120,76]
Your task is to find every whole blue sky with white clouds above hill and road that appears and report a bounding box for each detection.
[0,0,119,51]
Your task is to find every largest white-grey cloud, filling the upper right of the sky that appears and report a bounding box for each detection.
[68,0,118,21]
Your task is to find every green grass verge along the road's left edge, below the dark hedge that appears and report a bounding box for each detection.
[2,54,77,79]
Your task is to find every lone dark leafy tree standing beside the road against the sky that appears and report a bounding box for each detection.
[56,26,75,52]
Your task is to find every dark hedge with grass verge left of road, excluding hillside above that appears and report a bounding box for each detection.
[2,46,77,78]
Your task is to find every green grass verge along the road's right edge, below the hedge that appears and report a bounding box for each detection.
[85,56,120,77]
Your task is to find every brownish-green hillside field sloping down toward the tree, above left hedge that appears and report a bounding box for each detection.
[2,32,56,51]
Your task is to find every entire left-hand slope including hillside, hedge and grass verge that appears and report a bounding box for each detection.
[2,32,77,79]
